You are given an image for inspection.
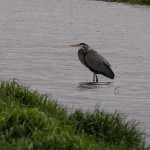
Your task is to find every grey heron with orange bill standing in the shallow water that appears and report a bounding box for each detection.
[71,43,115,82]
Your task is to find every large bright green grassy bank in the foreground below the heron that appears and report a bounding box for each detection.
[0,81,149,150]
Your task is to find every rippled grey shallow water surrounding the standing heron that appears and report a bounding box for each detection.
[0,0,150,143]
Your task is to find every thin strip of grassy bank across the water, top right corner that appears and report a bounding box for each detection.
[97,0,150,5]
